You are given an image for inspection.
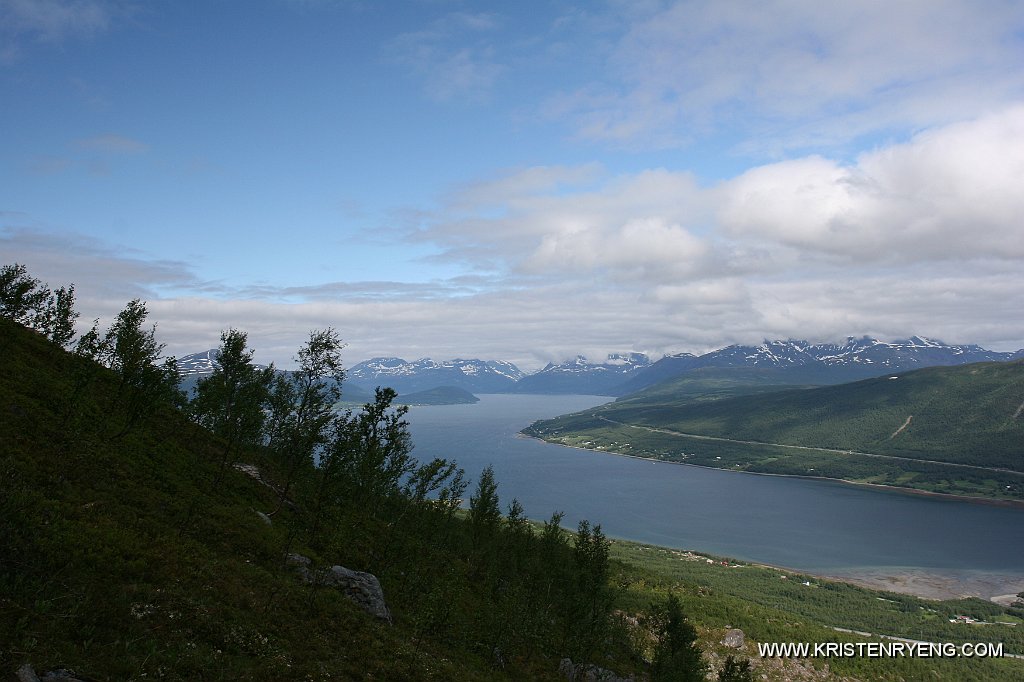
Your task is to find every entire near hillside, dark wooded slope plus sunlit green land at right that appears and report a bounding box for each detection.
[0,262,1024,680]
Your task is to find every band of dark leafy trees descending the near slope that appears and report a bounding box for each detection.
[0,264,751,680]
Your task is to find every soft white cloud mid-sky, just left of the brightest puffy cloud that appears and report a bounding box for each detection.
[420,166,720,279]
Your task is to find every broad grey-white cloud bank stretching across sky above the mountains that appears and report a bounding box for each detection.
[0,105,1024,368]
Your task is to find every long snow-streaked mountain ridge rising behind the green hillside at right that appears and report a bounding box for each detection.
[615,336,1024,395]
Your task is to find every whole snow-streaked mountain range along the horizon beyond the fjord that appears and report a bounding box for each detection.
[178,336,1024,400]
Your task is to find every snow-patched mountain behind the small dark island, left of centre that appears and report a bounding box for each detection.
[346,357,523,395]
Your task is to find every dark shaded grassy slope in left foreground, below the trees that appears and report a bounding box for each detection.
[0,319,528,680]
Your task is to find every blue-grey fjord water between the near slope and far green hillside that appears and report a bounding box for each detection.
[409,395,1024,581]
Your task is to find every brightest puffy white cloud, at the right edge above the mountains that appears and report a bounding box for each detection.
[719,105,1024,262]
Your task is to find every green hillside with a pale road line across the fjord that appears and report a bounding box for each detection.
[527,361,1024,500]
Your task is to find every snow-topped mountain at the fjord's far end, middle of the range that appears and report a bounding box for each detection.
[515,353,650,395]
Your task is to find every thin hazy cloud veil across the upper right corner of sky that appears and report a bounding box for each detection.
[548,0,1024,154]
